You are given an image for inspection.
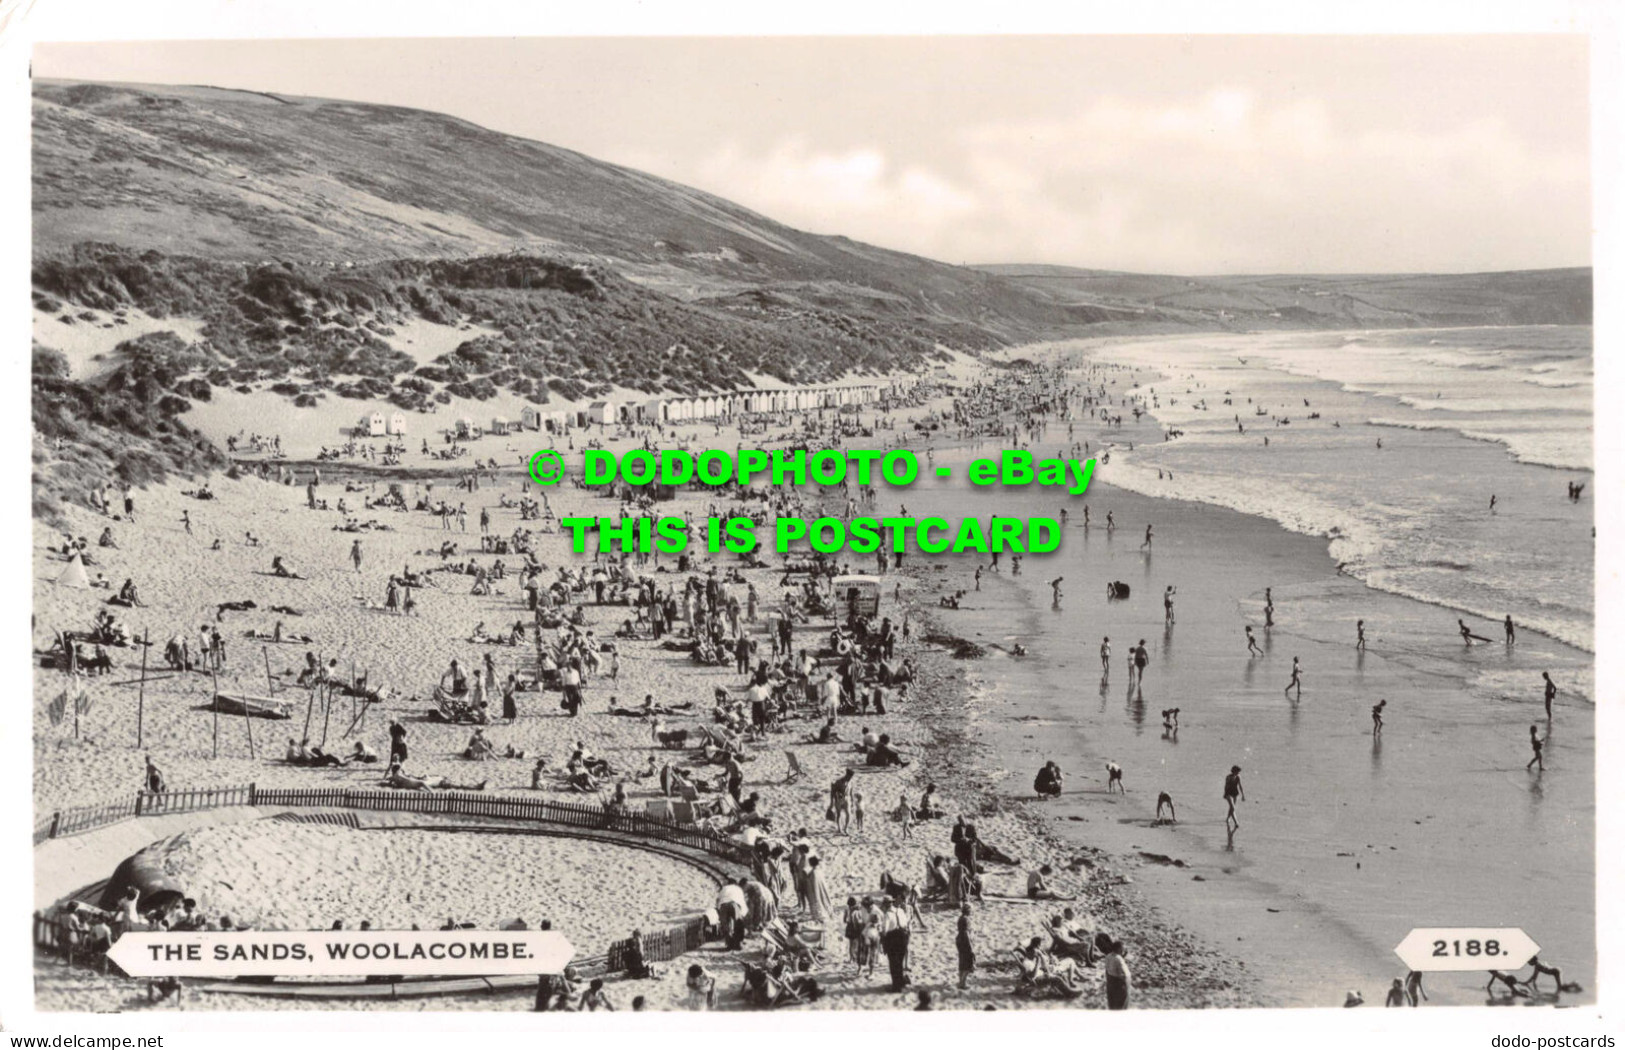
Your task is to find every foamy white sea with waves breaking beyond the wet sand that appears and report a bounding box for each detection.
[1094,327,1594,652]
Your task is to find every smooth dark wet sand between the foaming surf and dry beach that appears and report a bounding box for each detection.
[912,455,1596,1006]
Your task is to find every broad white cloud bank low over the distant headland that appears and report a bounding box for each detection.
[678,88,1589,273]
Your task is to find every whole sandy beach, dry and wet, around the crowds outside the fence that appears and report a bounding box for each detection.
[34,339,1594,1009]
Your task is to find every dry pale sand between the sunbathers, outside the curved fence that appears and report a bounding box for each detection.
[34,385,1255,1009]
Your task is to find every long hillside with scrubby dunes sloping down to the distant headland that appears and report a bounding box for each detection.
[33,81,1591,515]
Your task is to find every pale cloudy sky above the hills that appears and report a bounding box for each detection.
[33,34,1593,275]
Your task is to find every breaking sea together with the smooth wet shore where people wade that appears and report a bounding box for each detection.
[884,328,1596,1004]
